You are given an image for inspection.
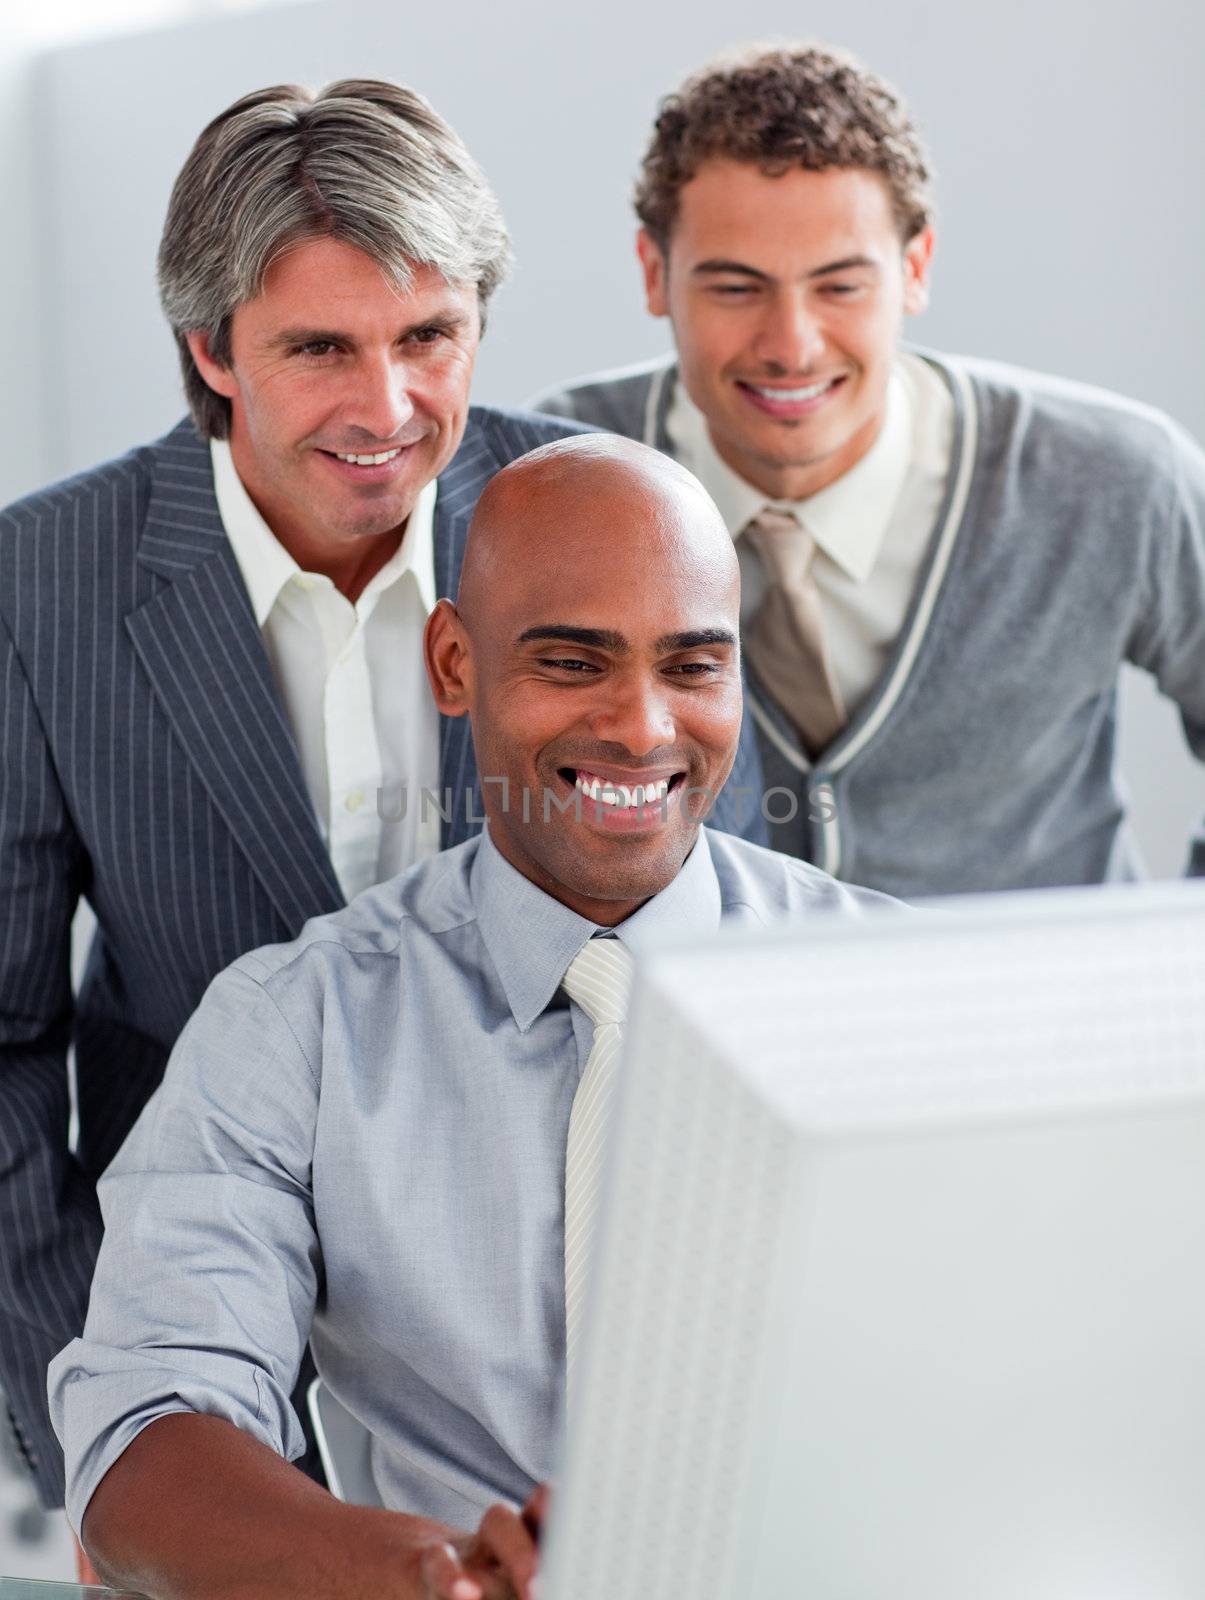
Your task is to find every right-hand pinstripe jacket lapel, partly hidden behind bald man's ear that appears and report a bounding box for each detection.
[435,413,502,850]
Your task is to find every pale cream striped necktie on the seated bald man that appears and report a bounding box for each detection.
[563,939,632,1386]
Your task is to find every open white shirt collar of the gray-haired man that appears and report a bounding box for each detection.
[210,438,438,627]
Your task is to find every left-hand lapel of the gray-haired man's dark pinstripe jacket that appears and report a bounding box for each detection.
[125,422,344,933]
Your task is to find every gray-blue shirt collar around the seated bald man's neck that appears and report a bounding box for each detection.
[469,829,720,1034]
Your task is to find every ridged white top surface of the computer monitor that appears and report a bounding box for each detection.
[691,891,1205,1131]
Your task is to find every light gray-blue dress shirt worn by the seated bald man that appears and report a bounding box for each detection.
[50,832,879,1528]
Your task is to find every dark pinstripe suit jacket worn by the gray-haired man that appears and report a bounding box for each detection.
[0,408,578,1501]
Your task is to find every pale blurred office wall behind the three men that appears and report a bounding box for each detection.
[0,0,1205,1576]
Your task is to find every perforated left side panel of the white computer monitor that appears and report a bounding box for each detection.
[552,987,792,1600]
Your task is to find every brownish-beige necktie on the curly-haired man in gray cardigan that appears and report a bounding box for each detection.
[744,507,847,755]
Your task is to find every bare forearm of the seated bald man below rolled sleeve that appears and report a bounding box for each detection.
[83,1413,467,1600]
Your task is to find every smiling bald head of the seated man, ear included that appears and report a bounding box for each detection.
[427,435,741,925]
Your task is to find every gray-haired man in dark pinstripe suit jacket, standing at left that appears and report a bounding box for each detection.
[0,80,659,1523]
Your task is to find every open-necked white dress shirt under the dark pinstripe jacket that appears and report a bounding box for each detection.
[210,438,440,899]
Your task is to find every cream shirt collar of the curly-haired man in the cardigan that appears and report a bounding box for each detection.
[666,362,914,582]
